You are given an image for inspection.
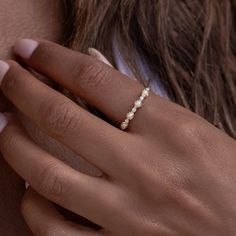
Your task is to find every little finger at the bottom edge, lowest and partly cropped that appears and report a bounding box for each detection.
[21,188,103,236]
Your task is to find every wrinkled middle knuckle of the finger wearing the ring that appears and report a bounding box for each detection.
[73,59,110,89]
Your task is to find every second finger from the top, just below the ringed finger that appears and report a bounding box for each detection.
[1,61,130,174]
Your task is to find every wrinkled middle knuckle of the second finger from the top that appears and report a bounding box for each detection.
[40,98,82,136]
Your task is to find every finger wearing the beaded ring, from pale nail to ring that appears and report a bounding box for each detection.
[14,39,148,126]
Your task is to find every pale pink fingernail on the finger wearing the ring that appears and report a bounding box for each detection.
[13,39,39,59]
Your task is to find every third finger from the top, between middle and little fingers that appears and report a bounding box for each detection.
[0,115,120,227]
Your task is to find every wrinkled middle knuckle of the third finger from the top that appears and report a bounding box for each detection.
[36,162,66,199]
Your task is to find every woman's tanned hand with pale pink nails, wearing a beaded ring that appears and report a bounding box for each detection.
[0,40,236,236]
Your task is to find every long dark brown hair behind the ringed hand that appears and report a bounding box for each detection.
[60,0,236,138]
